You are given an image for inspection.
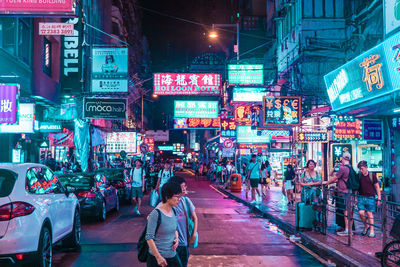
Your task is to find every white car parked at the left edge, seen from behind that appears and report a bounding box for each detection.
[0,163,81,266]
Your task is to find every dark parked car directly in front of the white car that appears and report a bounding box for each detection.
[59,173,119,222]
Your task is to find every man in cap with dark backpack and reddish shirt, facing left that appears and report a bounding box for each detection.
[323,151,360,236]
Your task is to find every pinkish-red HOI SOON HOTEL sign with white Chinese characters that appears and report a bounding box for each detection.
[153,73,221,95]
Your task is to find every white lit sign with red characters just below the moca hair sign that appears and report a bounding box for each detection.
[106,132,137,153]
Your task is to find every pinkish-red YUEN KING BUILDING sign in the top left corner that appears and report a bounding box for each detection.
[0,0,74,15]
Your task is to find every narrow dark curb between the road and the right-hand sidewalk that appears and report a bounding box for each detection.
[213,186,374,266]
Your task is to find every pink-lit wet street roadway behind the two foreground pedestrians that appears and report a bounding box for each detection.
[54,171,321,267]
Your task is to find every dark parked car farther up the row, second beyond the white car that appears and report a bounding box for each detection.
[95,168,132,203]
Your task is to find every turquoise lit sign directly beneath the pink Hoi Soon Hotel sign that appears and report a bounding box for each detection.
[174,100,218,119]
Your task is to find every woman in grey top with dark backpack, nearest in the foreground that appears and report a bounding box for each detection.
[146,182,182,267]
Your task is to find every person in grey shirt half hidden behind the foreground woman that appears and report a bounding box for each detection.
[170,176,198,267]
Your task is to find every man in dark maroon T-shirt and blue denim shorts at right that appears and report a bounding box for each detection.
[357,160,381,238]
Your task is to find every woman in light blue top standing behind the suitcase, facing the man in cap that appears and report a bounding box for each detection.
[300,159,322,204]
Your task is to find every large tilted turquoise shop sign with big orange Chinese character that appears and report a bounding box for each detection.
[324,30,400,111]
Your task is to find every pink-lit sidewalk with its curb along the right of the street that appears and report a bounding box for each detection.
[216,185,382,266]
